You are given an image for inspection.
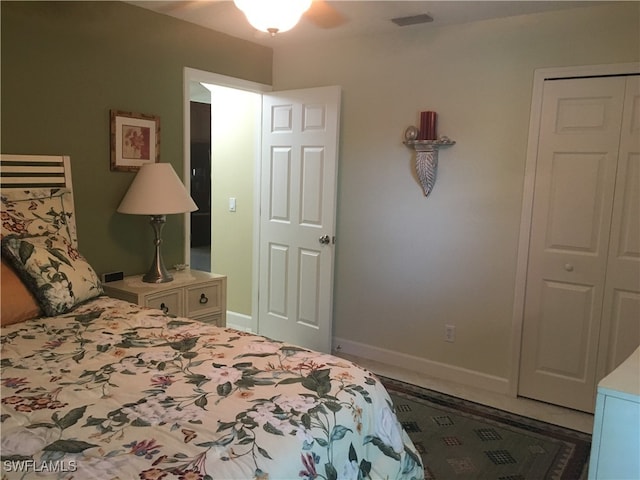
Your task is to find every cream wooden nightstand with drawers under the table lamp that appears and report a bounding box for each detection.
[103,270,227,327]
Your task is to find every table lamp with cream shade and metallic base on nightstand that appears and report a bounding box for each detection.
[117,163,198,283]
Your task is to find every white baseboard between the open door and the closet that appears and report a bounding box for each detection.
[333,337,510,394]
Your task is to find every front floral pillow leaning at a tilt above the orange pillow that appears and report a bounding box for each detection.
[2,236,104,317]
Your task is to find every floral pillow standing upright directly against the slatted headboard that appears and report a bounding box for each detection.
[0,188,78,248]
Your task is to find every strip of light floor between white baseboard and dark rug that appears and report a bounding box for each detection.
[337,353,593,434]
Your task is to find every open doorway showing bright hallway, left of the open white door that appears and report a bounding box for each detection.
[184,68,270,332]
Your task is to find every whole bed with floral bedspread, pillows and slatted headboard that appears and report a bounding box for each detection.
[0,156,424,480]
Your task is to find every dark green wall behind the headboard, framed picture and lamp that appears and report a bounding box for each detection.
[0,1,272,274]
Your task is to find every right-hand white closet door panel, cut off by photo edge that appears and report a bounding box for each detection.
[598,76,640,379]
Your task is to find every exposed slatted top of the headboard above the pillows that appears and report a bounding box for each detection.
[0,154,72,189]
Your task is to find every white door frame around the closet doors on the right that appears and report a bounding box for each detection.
[508,62,640,397]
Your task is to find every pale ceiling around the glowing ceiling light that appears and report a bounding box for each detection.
[128,0,605,48]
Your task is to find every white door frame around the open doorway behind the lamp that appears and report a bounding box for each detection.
[182,67,273,332]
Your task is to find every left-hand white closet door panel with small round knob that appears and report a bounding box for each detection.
[518,77,625,411]
